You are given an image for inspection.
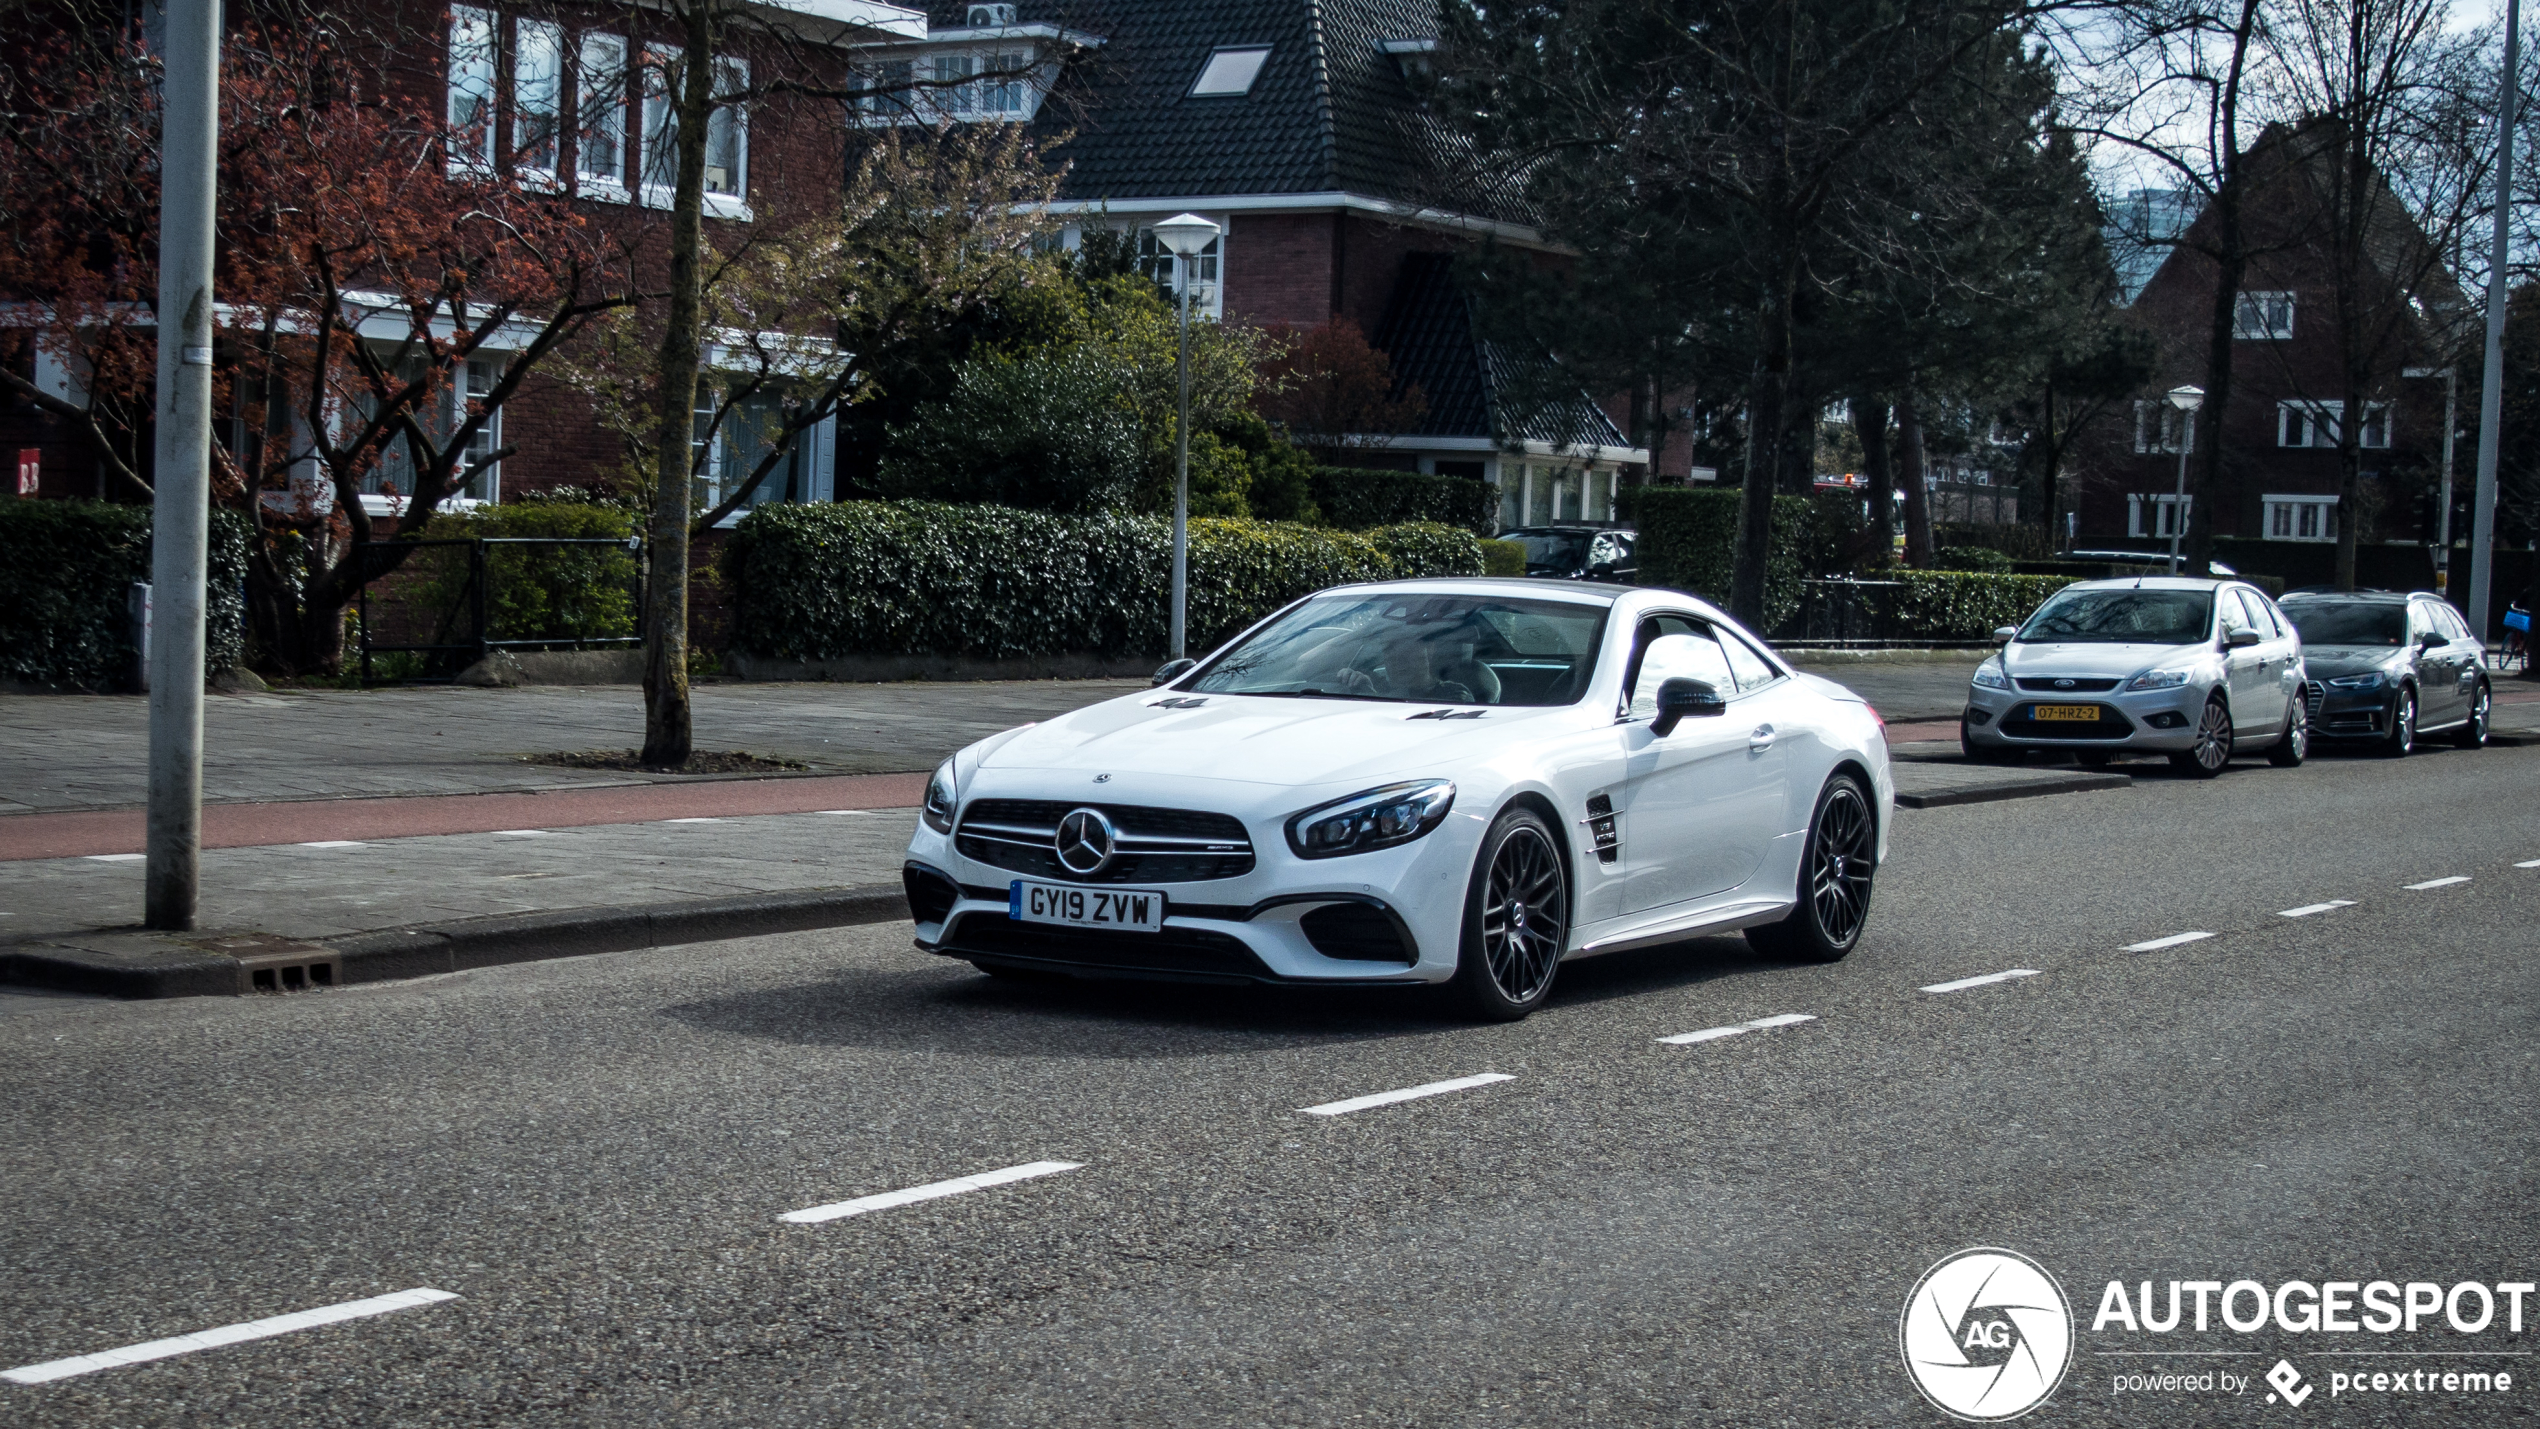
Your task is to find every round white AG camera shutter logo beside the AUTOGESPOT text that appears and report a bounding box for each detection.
[1897,1246,2073,1421]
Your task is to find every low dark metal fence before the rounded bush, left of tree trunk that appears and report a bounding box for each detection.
[353,536,643,685]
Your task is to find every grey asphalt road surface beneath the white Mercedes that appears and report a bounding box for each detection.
[0,749,2540,1426]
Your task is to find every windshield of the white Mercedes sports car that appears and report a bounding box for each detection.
[1184,594,1605,706]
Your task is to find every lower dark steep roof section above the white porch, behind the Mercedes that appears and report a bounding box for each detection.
[1374,254,1631,447]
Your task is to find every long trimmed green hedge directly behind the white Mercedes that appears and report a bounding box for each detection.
[721,503,1481,660]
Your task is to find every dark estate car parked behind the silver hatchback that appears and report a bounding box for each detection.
[2283,591,2494,754]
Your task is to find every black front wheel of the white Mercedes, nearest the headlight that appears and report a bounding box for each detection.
[1453,810,1570,1023]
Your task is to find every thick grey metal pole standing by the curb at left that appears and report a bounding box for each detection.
[142,0,221,932]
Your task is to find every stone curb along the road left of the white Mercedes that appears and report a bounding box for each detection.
[0,883,909,998]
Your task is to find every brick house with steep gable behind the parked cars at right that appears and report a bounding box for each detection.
[2057,132,2477,548]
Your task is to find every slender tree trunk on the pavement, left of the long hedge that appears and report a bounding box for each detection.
[640,11,714,769]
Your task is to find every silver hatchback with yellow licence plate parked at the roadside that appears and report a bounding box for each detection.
[1958,576,2309,779]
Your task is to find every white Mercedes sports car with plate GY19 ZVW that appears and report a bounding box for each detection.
[904,579,1895,1018]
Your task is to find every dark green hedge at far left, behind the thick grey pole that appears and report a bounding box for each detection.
[0,500,249,690]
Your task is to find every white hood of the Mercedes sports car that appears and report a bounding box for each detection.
[980,690,1580,792]
